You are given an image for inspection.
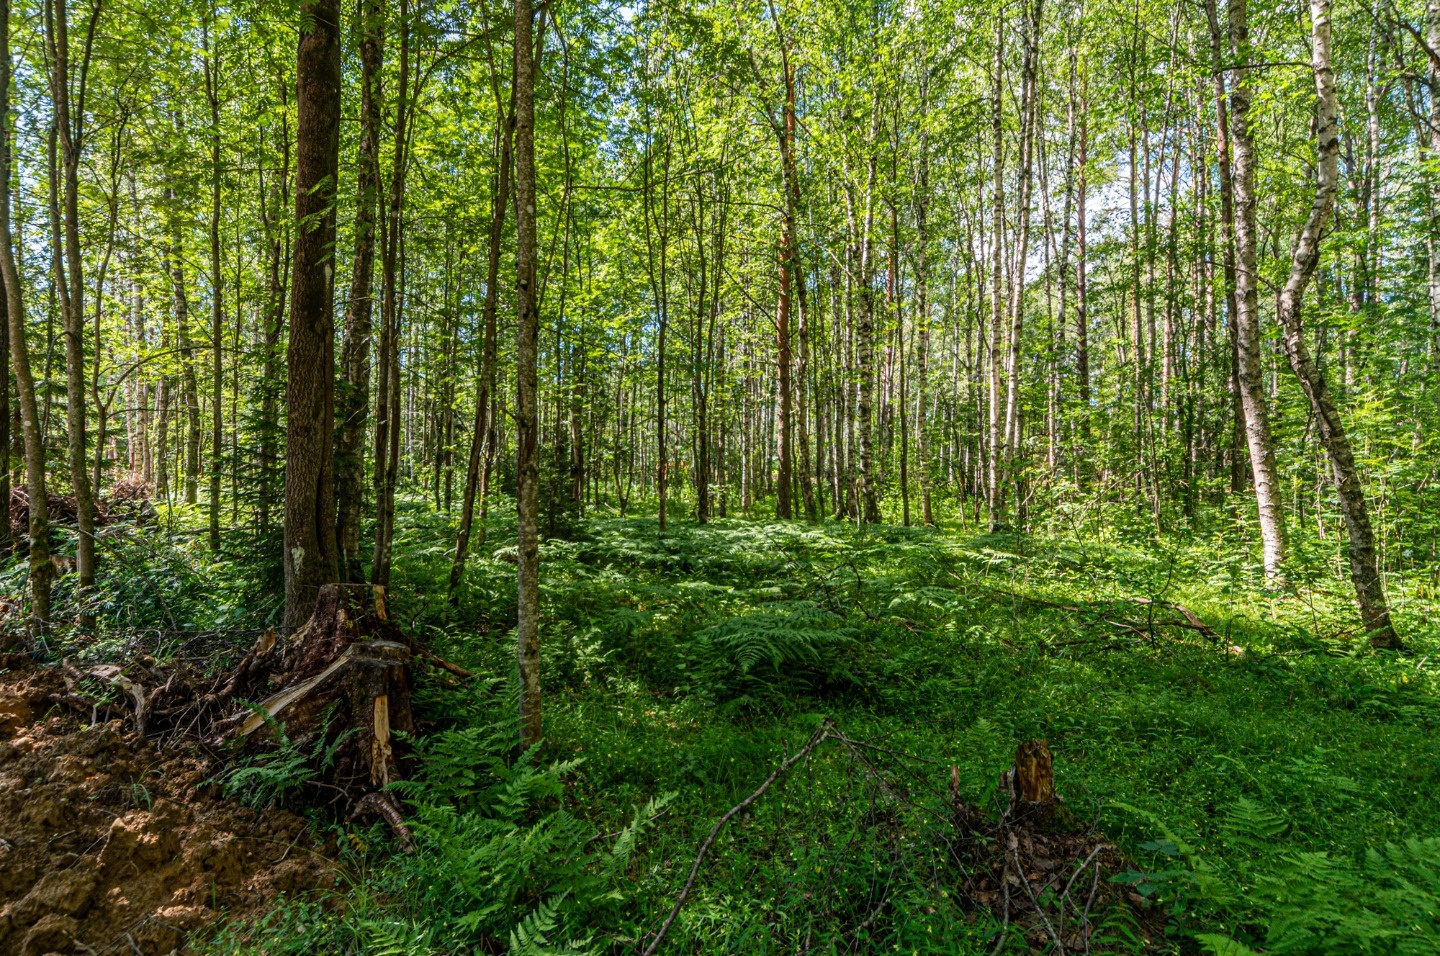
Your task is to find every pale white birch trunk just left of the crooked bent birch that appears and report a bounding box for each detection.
[1230,0,1284,577]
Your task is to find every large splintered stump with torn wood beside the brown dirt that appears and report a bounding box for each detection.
[220,585,415,789]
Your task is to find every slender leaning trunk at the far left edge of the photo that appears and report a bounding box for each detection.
[0,0,50,639]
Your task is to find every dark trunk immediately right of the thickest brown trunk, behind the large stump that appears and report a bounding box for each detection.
[336,0,384,583]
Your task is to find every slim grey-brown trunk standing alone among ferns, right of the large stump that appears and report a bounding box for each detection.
[514,0,541,750]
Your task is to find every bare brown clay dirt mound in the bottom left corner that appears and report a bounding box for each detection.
[0,655,338,956]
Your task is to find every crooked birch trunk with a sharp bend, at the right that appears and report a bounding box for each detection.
[1276,0,1401,649]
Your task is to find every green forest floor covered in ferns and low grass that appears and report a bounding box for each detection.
[8,501,1440,955]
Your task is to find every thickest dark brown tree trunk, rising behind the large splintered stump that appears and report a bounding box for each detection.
[285,0,340,628]
